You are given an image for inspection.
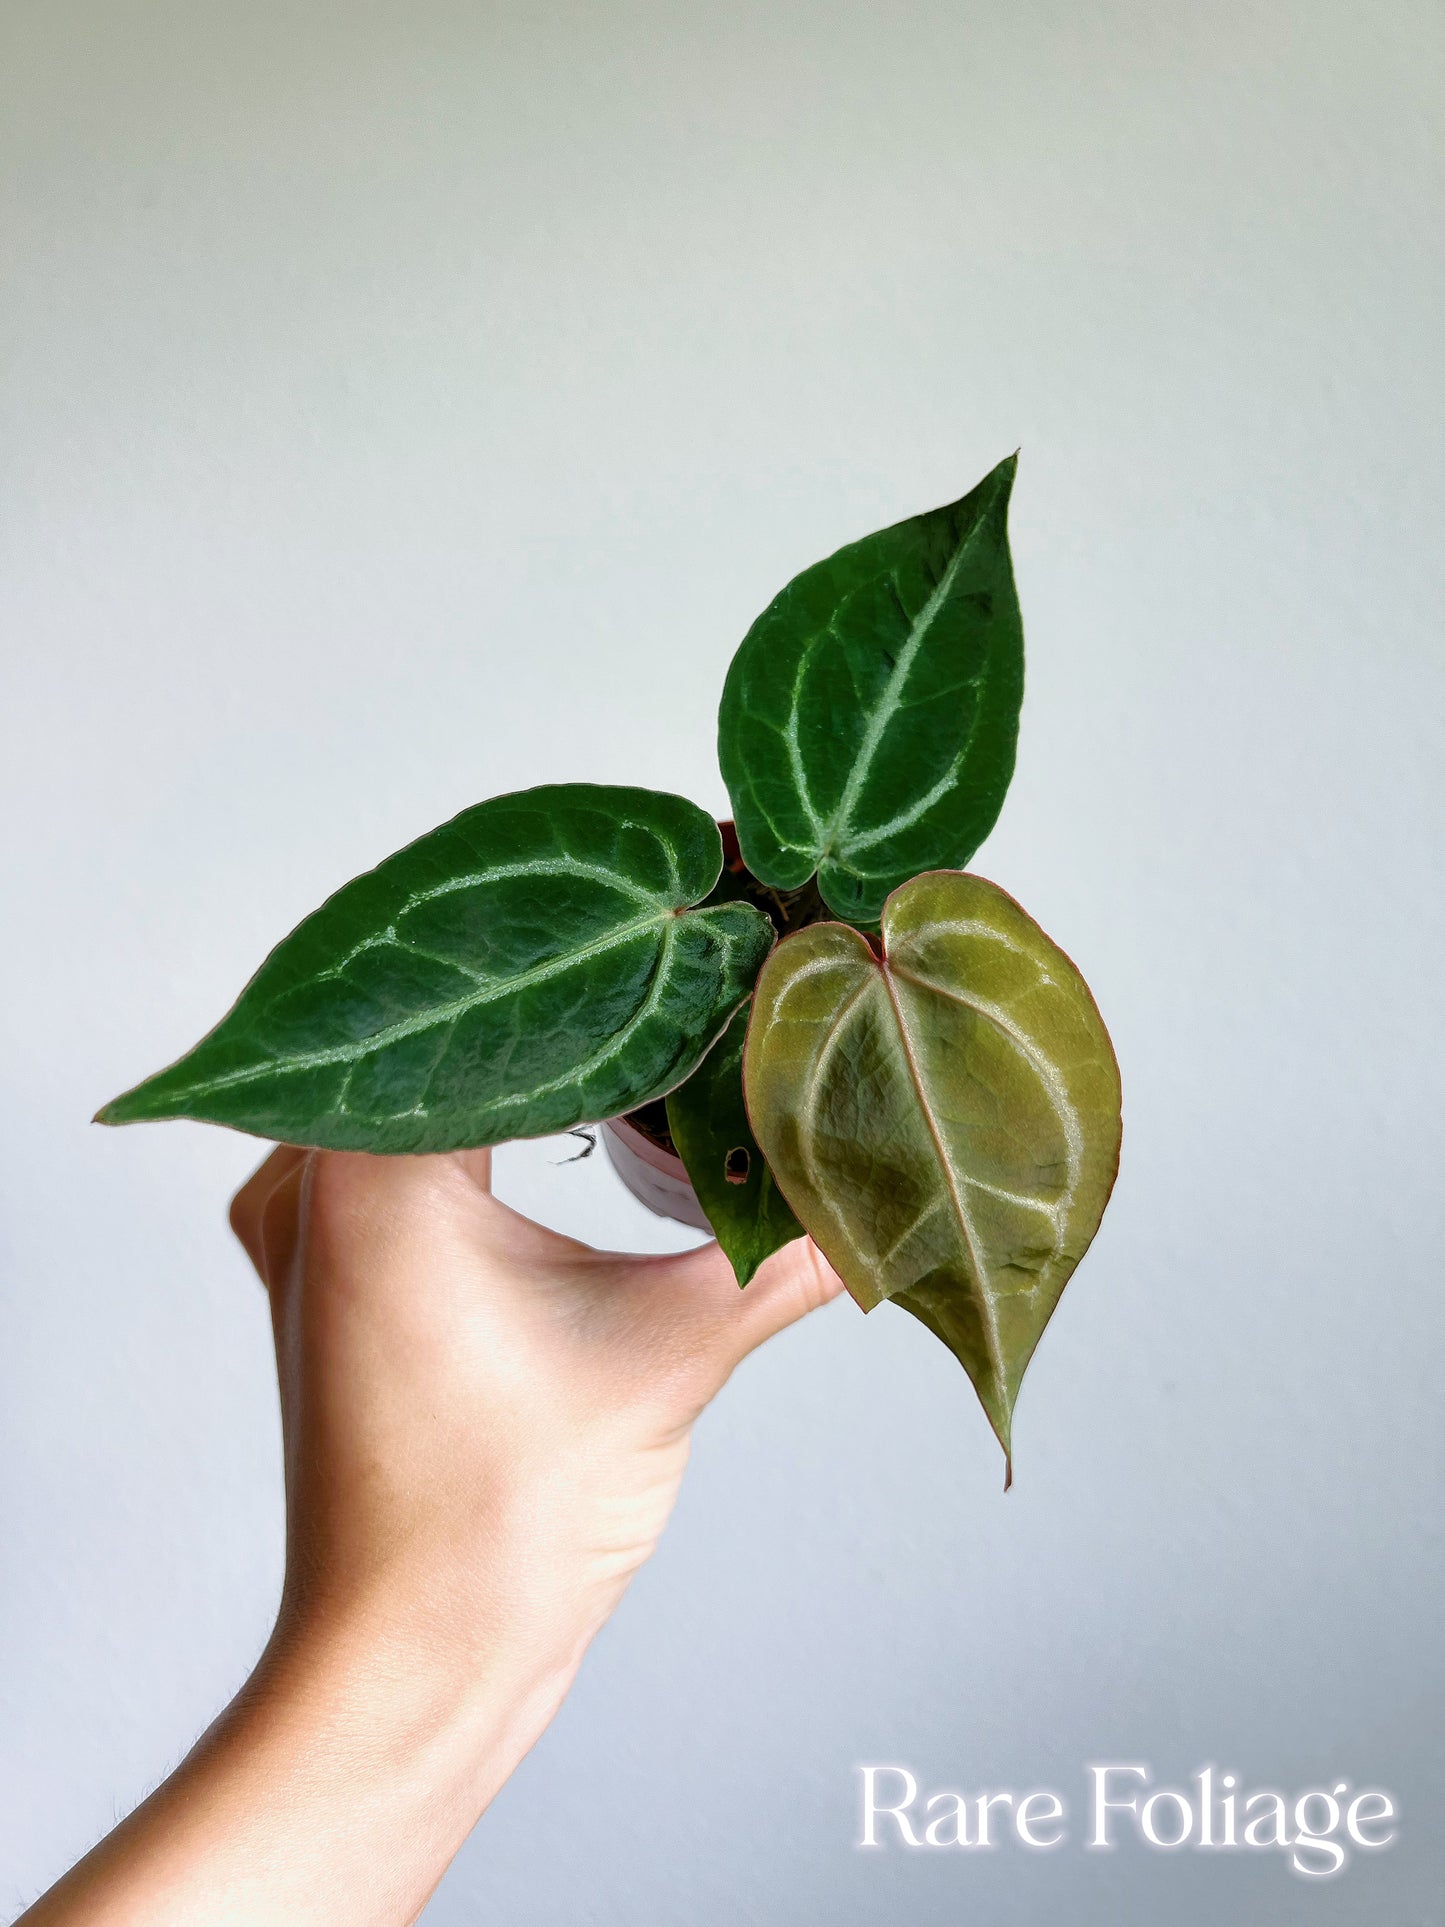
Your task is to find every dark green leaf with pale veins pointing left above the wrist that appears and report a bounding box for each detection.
[100,782,773,1152]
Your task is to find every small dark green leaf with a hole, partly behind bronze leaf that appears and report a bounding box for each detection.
[667,1006,803,1285]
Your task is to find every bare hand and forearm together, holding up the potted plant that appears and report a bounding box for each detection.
[21,1148,842,1927]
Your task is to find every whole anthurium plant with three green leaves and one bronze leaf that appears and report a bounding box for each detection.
[100,459,1119,1455]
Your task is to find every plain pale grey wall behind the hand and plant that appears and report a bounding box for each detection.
[0,0,1445,1927]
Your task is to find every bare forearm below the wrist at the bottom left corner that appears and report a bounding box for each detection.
[23,1595,570,1927]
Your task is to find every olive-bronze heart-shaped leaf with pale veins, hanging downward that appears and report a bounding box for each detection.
[744,871,1119,1457]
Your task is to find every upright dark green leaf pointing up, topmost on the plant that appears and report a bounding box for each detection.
[719,457,1023,923]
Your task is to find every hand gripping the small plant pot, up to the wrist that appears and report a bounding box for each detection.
[231,1148,842,1726]
